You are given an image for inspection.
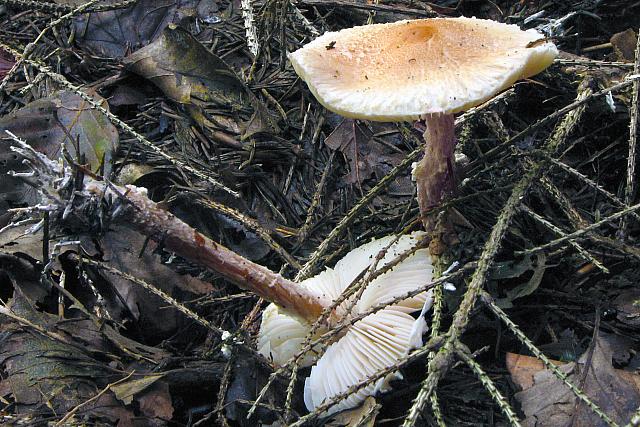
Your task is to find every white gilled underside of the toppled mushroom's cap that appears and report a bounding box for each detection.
[258,232,433,415]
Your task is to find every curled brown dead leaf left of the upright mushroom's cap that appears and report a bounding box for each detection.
[124,25,278,139]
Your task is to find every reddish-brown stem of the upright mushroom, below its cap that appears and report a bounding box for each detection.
[413,114,456,233]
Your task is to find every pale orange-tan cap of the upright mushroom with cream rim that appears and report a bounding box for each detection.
[289,18,558,121]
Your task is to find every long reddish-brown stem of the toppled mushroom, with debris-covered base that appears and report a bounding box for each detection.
[9,133,330,322]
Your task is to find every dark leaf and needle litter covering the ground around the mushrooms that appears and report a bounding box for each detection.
[0,0,640,425]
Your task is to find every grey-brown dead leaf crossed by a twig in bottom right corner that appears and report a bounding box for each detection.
[508,337,640,427]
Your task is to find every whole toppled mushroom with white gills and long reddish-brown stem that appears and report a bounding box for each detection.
[7,121,440,413]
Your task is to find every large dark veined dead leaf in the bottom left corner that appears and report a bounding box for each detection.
[0,293,134,423]
